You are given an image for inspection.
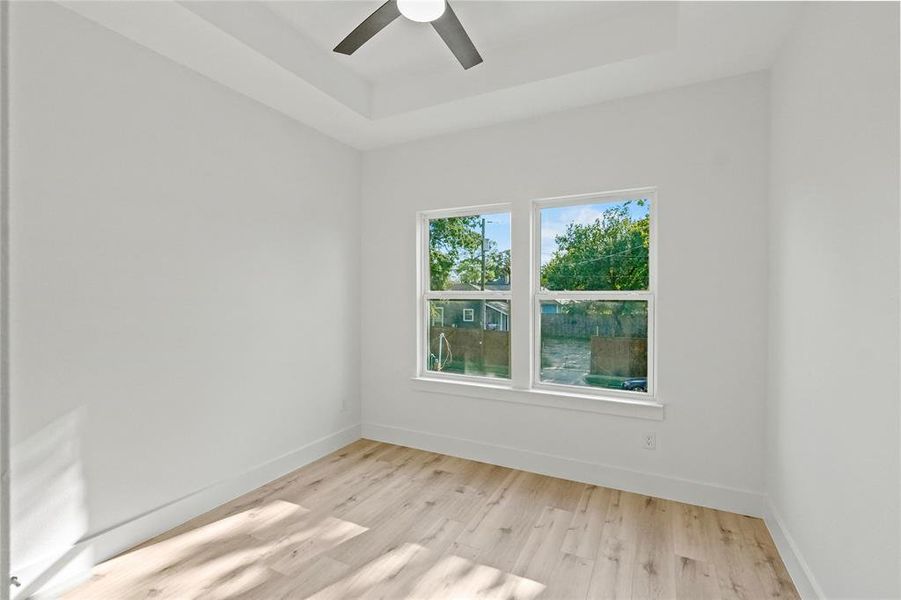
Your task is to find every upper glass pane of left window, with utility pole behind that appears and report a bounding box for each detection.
[429,213,510,291]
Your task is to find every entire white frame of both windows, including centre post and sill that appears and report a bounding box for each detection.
[413,187,664,421]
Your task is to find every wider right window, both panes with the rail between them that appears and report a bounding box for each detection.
[534,195,653,393]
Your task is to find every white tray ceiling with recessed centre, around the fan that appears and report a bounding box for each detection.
[62,0,802,149]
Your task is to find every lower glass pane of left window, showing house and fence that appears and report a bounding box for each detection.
[427,300,510,379]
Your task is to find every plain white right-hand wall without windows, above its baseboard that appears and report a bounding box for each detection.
[767,3,901,598]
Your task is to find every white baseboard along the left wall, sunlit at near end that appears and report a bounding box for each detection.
[13,424,360,599]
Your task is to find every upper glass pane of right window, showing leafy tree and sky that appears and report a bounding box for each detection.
[541,199,651,291]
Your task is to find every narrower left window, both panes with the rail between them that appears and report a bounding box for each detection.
[422,211,511,379]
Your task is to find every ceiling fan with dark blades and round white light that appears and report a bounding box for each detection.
[335,0,482,69]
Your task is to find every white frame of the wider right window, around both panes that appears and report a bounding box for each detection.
[531,188,657,400]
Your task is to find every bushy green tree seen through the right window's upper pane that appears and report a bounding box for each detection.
[541,200,650,291]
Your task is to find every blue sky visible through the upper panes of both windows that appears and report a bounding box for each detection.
[472,202,651,265]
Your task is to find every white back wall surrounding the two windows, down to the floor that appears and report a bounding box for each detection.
[361,73,769,513]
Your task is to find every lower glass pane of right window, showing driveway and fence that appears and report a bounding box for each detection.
[540,300,648,392]
